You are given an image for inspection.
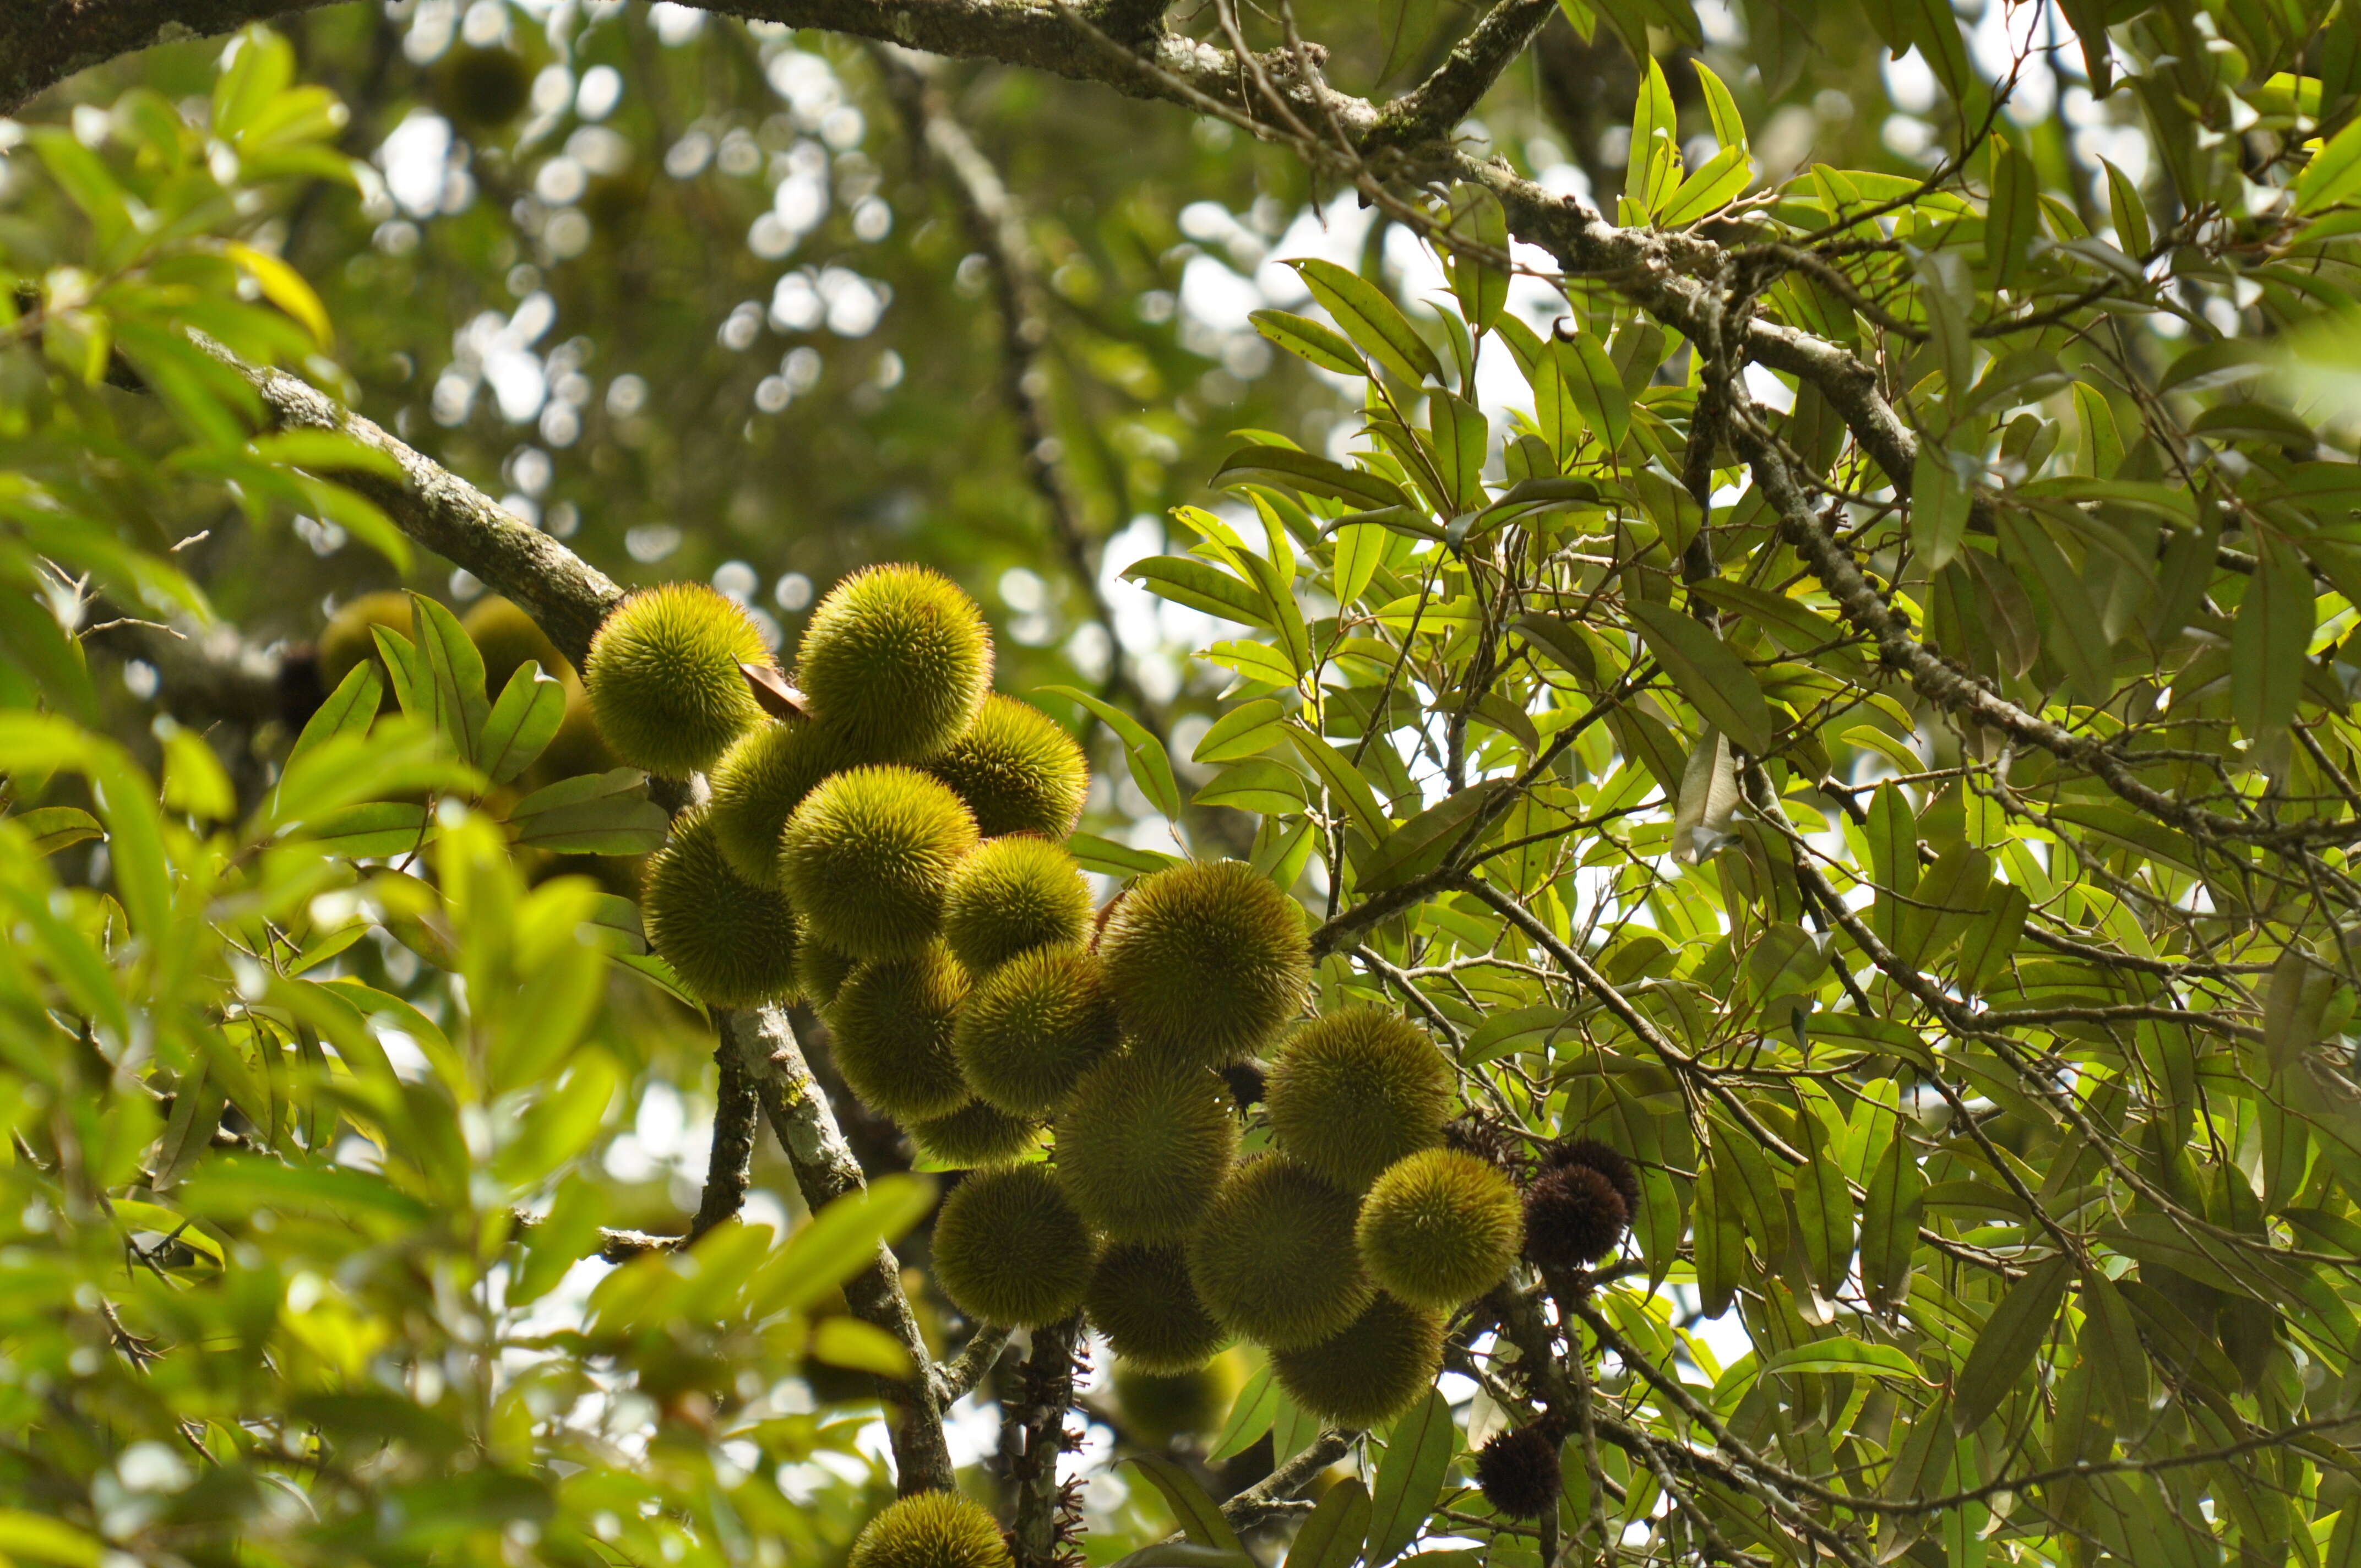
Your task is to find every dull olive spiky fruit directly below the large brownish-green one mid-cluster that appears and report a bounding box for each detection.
[1058,1051,1237,1242]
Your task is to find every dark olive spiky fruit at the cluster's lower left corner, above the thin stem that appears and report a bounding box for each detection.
[935,1164,1091,1330]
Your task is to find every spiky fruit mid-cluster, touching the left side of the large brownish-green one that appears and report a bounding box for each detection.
[954,942,1114,1117]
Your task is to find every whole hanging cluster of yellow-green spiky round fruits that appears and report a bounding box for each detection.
[573,567,1605,1445]
